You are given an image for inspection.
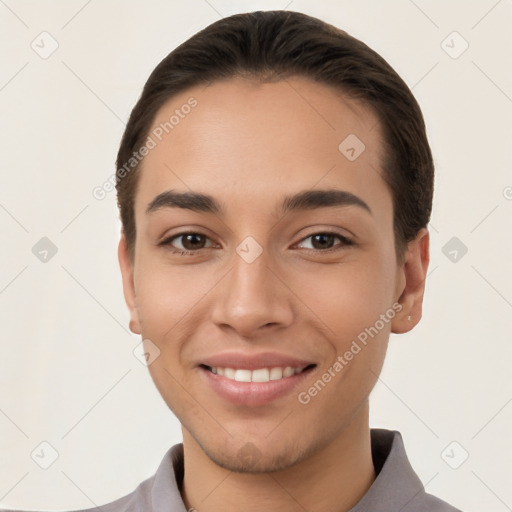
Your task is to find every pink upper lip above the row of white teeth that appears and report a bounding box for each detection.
[199,352,315,370]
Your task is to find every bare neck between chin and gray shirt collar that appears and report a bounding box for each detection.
[182,403,376,512]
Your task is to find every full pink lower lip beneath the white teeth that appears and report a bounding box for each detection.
[199,367,315,407]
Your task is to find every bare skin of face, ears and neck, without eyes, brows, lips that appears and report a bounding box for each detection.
[118,78,429,512]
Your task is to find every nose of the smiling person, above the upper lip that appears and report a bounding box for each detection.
[212,246,294,337]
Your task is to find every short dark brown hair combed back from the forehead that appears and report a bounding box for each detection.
[116,11,434,262]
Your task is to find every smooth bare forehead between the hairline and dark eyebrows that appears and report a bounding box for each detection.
[135,77,390,216]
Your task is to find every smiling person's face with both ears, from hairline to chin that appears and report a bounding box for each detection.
[119,78,428,471]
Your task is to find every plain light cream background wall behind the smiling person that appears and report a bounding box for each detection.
[0,0,512,512]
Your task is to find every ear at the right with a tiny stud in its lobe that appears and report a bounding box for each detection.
[391,228,430,334]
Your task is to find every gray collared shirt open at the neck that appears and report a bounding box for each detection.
[0,429,461,512]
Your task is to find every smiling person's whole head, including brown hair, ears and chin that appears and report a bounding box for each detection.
[116,11,433,471]
